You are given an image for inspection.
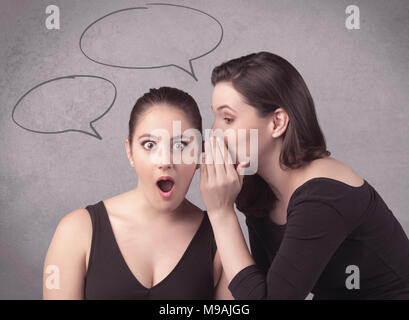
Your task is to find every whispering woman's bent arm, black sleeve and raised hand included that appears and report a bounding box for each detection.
[200,136,351,299]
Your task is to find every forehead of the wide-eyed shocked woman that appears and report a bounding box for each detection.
[135,104,193,135]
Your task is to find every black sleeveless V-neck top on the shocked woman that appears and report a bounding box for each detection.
[84,201,216,300]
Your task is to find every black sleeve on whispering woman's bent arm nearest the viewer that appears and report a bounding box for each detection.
[228,201,353,299]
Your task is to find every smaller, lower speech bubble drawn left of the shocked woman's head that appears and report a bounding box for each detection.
[11,75,117,140]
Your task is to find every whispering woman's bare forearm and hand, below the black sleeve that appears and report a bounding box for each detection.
[200,137,254,282]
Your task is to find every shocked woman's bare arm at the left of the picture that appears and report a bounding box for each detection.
[43,209,92,299]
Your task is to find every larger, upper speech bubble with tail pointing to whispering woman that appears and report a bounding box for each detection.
[79,3,223,81]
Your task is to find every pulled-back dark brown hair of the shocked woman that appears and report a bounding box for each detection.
[128,87,202,145]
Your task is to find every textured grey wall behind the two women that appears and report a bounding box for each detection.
[0,0,409,299]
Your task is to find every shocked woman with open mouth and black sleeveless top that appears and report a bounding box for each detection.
[43,87,232,299]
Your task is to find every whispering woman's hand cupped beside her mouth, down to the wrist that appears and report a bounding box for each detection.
[200,136,248,214]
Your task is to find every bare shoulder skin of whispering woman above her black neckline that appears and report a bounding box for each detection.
[306,157,364,187]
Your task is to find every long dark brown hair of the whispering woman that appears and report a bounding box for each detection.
[211,52,331,216]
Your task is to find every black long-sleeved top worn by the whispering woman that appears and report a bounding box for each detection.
[229,177,409,299]
